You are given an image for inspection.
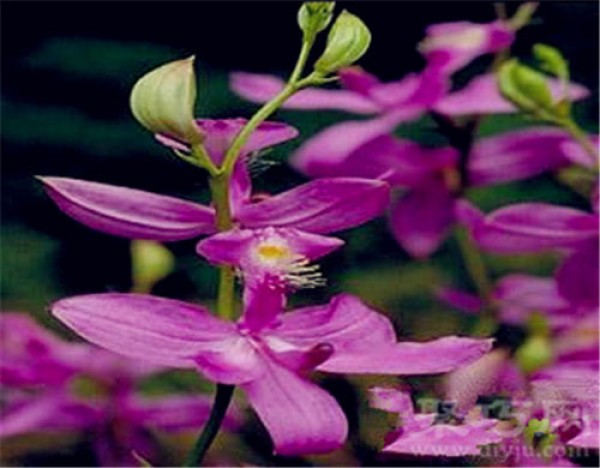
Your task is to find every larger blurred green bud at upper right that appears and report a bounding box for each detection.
[498,59,554,120]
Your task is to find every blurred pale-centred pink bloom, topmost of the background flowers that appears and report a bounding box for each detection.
[419,21,515,75]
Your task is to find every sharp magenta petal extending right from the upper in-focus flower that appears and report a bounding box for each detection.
[237,178,389,234]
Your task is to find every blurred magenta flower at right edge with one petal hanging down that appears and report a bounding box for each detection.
[457,202,599,307]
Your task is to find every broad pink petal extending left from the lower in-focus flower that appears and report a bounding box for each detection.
[52,294,235,367]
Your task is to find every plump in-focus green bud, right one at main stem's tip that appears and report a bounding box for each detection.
[315,10,371,74]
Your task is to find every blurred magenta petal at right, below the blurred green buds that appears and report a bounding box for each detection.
[469,128,568,185]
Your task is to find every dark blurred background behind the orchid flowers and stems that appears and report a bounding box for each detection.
[1,1,598,465]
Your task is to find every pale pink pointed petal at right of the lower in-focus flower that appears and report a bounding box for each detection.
[318,336,492,375]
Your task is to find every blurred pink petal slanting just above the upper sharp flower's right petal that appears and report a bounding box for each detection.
[291,114,414,177]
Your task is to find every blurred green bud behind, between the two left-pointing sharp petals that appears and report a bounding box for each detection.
[131,240,175,293]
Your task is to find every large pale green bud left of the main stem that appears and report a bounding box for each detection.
[129,56,203,144]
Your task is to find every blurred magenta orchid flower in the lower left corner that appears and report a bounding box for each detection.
[0,313,240,466]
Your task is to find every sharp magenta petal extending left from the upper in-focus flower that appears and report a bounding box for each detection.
[40,177,215,241]
